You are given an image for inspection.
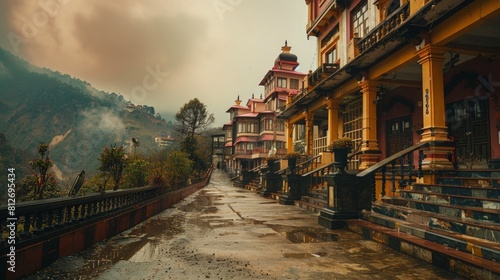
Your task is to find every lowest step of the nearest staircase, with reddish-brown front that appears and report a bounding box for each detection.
[346,220,500,279]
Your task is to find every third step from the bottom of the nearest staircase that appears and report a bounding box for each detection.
[372,202,500,242]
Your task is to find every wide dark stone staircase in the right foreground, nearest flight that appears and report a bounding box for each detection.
[347,171,500,279]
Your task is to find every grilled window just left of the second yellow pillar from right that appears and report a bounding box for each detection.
[343,98,363,169]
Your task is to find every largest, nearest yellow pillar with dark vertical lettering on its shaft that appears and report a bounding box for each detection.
[417,44,453,170]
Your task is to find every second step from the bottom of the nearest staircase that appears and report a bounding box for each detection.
[362,211,500,261]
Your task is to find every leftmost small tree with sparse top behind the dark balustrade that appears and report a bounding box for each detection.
[16,143,61,201]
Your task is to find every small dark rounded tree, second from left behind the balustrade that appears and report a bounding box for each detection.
[98,145,127,191]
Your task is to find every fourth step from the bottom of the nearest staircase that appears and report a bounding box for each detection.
[383,197,500,223]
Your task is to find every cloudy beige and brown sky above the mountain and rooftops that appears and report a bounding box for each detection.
[0,0,316,126]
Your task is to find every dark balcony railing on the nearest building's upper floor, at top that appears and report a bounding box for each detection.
[358,2,410,54]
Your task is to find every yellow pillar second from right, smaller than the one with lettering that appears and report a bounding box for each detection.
[359,80,380,170]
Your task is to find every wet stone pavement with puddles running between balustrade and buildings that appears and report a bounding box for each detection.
[28,171,460,280]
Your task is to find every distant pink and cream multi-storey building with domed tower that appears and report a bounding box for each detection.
[223,42,306,175]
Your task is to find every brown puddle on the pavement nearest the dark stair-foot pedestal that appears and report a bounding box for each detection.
[267,225,339,243]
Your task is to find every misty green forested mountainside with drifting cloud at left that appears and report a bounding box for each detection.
[0,48,171,186]
